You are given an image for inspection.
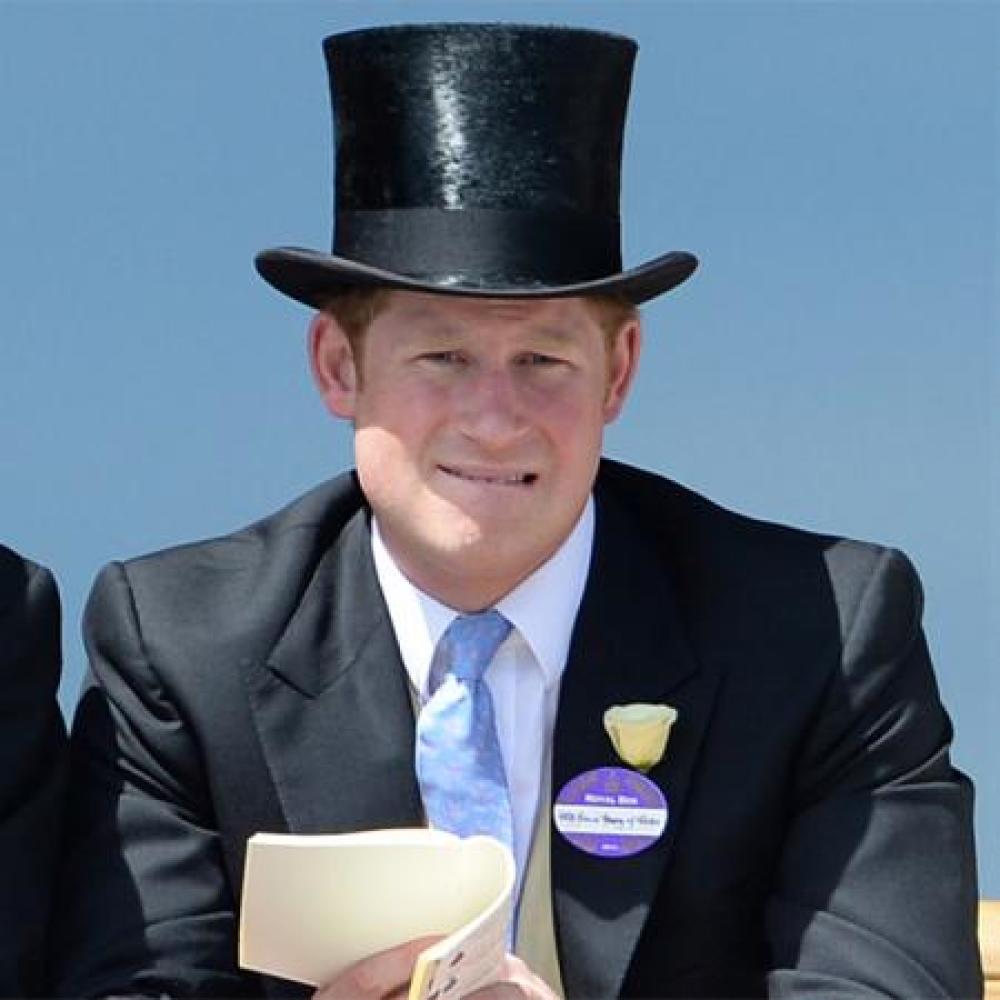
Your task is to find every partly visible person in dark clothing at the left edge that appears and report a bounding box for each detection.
[0,545,66,997]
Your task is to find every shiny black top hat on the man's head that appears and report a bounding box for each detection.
[256,24,698,307]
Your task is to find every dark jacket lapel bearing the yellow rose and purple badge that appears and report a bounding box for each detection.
[552,484,717,997]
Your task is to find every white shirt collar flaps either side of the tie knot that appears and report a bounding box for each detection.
[372,497,594,698]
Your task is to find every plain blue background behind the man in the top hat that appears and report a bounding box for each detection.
[0,0,1000,896]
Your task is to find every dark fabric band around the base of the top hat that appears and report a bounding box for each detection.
[333,208,621,290]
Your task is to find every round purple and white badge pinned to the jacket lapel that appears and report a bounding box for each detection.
[552,767,669,858]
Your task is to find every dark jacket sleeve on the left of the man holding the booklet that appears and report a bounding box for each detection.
[51,564,259,997]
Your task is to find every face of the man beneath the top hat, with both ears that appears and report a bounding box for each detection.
[311,292,639,610]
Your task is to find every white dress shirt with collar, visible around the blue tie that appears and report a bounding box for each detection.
[372,498,594,894]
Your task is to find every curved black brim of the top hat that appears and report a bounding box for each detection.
[254,247,698,309]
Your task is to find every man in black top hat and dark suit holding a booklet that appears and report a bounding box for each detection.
[55,25,981,998]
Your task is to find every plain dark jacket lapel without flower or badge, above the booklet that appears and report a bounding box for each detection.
[247,512,423,833]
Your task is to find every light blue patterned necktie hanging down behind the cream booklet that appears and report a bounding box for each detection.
[417,611,513,849]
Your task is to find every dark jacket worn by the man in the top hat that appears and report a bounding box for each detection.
[53,462,981,998]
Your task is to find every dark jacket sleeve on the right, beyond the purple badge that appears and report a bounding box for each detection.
[767,550,982,1000]
